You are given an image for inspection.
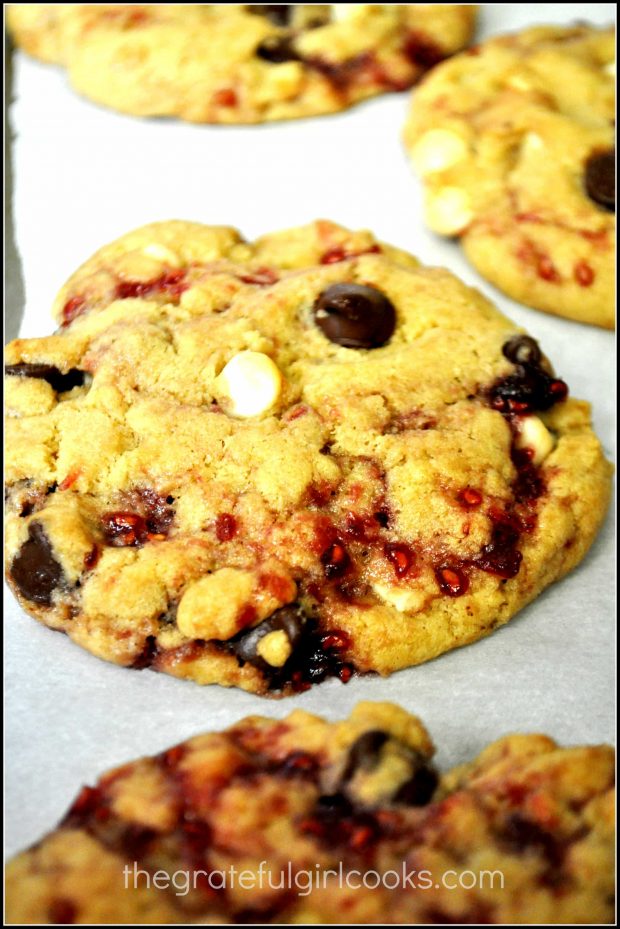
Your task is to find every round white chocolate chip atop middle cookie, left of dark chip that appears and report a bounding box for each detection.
[216,351,282,418]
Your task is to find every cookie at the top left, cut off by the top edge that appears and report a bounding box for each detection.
[8,3,475,123]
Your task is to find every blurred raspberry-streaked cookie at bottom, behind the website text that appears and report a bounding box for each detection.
[6,703,615,925]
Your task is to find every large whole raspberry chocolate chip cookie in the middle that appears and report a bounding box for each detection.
[6,221,610,694]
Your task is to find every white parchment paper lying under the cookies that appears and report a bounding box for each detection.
[5,3,615,854]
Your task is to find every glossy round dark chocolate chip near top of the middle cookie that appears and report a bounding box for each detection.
[314,284,396,348]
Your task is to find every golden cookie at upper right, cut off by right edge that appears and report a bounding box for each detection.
[405,25,615,329]
